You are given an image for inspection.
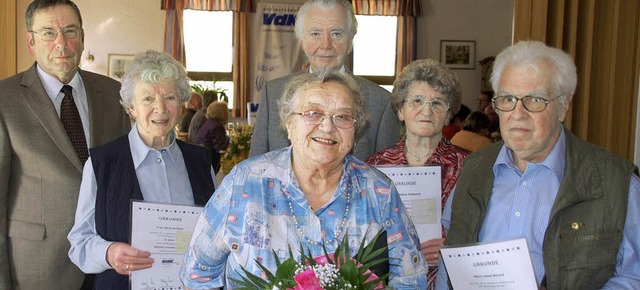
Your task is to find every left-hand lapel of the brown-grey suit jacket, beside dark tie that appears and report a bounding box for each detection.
[20,64,83,172]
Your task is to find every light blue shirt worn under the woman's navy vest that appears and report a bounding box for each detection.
[67,124,215,273]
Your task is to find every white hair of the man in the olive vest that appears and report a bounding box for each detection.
[491,40,578,110]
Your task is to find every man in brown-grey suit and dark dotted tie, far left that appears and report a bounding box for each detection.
[0,0,130,290]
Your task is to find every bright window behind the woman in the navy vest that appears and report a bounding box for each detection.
[183,10,233,108]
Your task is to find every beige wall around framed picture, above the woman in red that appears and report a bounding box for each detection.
[417,0,513,110]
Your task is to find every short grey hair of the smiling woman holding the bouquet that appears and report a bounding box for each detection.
[278,70,369,139]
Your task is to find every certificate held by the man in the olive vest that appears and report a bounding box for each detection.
[440,239,538,290]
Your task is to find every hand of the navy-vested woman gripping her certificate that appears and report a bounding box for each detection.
[107,242,153,275]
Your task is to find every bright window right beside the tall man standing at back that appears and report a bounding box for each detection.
[353,15,398,91]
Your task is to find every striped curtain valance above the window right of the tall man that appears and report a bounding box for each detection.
[351,0,422,17]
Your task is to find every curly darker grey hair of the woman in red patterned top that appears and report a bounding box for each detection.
[391,58,462,116]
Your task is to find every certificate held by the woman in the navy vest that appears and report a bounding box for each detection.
[130,201,202,290]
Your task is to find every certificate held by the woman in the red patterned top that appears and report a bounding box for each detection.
[376,165,442,242]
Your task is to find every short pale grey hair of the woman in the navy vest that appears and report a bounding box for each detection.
[120,50,191,114]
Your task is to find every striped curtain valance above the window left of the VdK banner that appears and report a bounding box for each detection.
[161,0,254,12]
